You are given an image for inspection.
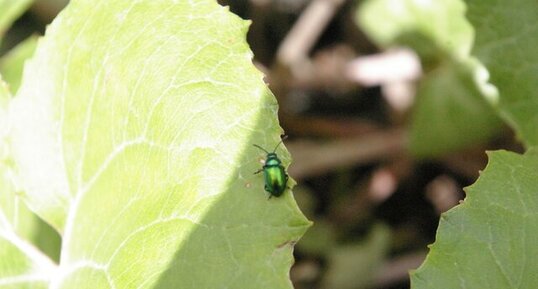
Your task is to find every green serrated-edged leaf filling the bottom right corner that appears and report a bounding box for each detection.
[411,148,538,289]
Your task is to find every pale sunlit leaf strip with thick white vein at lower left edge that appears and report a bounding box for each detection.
[0,79,55,289]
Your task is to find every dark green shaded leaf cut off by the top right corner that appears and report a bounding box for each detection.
[467,0,538,146]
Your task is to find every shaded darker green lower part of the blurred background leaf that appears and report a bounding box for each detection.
[410,62,500,156]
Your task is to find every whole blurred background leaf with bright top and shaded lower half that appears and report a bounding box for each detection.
[358,0,501,157]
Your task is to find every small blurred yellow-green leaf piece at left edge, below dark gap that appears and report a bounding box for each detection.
[0,35,39,94]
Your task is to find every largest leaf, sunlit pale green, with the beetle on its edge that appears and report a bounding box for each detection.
[10,0,310,288]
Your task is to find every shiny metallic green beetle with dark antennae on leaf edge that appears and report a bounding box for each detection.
[254,136,288,199]
